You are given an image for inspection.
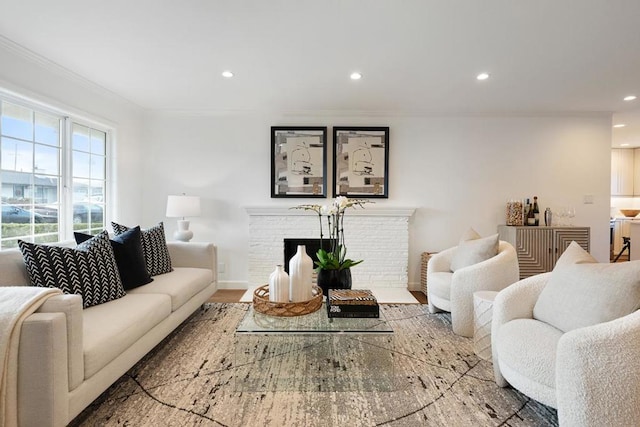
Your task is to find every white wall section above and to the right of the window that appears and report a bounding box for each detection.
[0,37,143,227]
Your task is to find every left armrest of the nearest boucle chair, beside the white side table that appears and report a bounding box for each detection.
[491,273,551,387]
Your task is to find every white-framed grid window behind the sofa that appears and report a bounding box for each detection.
[0,98,108,249]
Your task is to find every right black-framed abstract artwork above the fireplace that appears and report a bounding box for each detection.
[333,126,389,199]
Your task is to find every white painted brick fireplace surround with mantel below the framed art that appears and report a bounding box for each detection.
[247,206,414,289]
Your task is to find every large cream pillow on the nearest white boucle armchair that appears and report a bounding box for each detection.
[533,242,640,332]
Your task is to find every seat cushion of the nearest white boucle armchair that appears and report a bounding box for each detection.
[492,319,562,389]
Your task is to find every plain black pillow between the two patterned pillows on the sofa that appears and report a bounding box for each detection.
[73,227,153,290]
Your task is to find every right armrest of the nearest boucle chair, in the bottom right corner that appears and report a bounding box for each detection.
[556,311,640,426]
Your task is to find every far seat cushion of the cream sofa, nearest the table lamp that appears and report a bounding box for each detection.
[129,267,213,311]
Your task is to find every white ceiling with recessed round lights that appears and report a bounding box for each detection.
[0,0,640,146]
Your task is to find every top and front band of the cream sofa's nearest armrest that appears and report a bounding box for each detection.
[37,295,84,391]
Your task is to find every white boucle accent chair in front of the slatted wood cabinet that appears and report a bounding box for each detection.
[427,235,520,337]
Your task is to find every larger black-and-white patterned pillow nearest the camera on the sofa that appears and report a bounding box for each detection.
[18,231,126,308]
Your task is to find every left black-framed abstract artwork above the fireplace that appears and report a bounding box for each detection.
[271,126,327,198]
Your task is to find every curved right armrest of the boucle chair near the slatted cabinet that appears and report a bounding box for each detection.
[451,241,520,337]
